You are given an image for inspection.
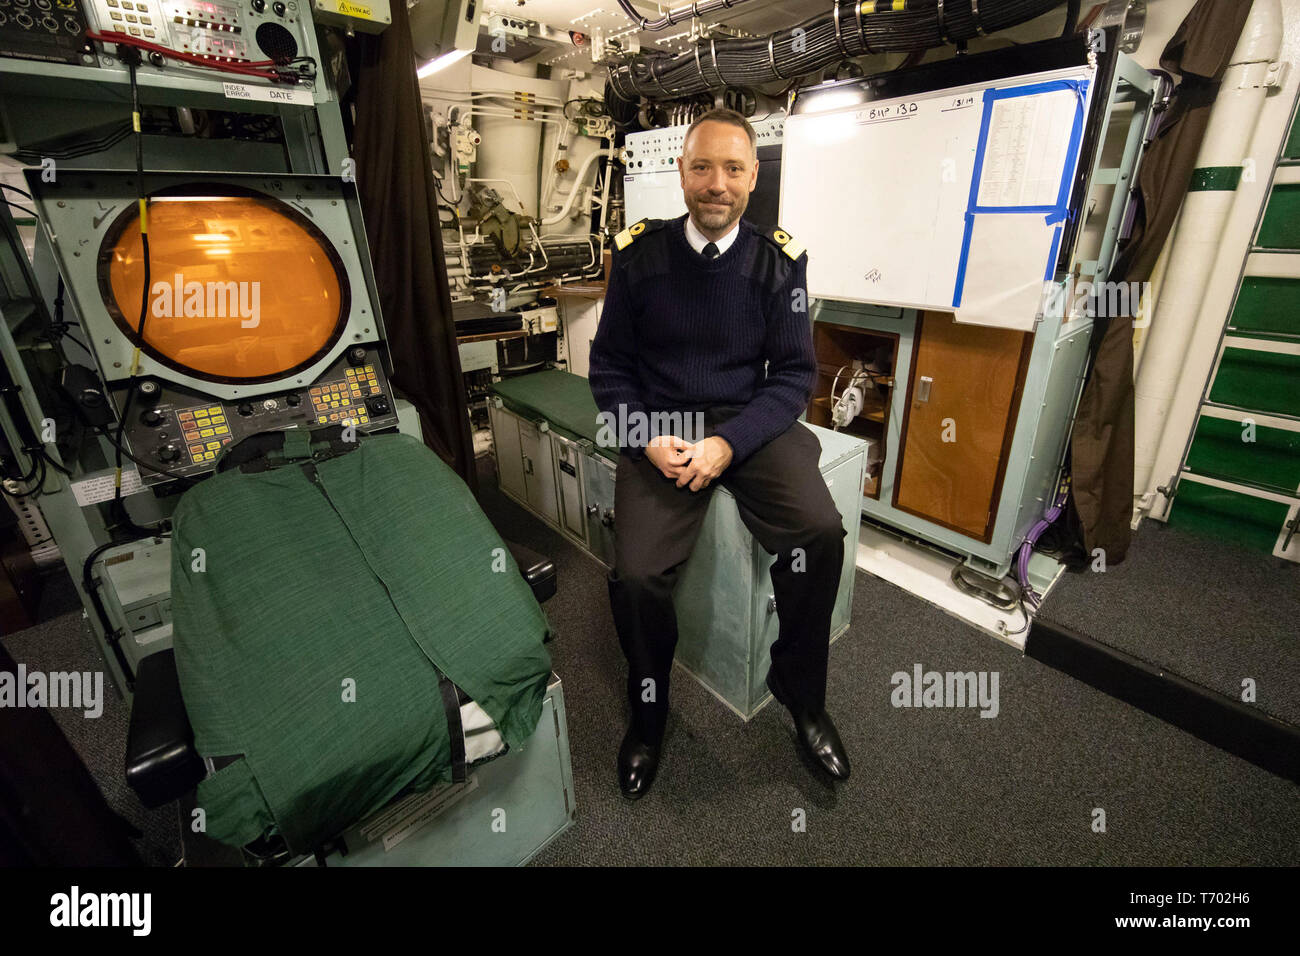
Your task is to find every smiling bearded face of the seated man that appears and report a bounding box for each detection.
[677,120,758,239]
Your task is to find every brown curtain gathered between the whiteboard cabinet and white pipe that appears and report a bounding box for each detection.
[1069,0,1251,564]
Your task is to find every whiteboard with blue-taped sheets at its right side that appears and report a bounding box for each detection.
[780,66,1092,329]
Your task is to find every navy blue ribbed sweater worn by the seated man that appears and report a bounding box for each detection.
[588,216,816,464]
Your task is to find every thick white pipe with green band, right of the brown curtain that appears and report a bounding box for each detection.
[1134,0,1282,519]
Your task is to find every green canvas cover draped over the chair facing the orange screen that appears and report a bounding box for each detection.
[172,432,551,852]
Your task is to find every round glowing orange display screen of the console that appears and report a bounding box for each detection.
[99,194,348,382]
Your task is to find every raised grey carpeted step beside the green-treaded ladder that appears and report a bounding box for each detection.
[1043,522,1300,726]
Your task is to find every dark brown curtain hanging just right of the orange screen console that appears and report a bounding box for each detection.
[351,9,478,493]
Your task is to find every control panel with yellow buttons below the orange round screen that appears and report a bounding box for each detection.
[114,346,398,485]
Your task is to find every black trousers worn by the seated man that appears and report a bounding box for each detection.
[608,406,848,744]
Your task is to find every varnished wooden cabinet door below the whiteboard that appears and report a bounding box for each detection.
[893,312,1034,542]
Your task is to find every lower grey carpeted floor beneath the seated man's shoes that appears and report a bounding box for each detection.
[5,466,1300,865]
